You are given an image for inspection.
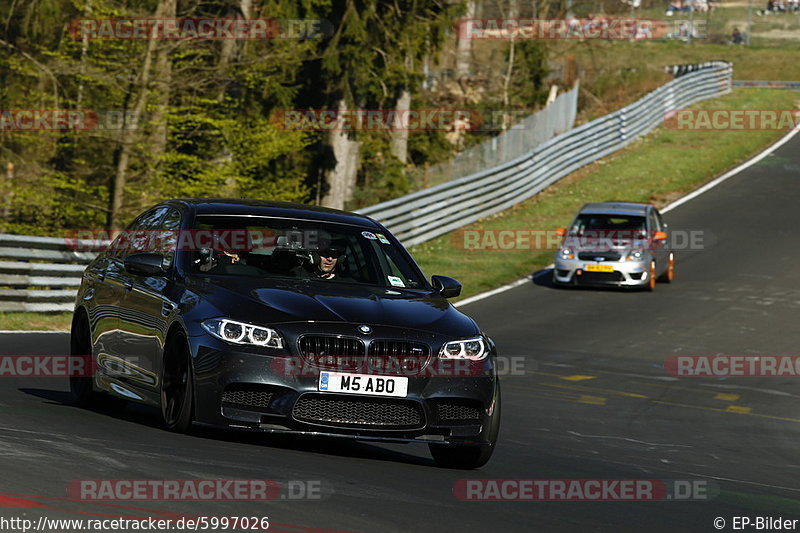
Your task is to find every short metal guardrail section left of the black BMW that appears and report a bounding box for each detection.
[0,234,95,312]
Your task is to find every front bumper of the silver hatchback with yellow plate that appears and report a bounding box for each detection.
[553,258,650,287]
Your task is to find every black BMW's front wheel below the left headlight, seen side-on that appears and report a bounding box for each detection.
[161,334,194,433]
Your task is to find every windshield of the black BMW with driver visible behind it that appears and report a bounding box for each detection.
[190,215,426,289]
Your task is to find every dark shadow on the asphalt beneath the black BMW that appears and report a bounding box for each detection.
[18,388,435,466]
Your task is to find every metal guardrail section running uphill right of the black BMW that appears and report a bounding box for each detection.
[358,61,733,246]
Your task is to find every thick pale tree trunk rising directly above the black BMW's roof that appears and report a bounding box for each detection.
[322,99,360,209]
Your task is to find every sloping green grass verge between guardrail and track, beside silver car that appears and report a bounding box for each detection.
[411,89,798,298]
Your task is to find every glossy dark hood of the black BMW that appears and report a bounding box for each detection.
[184,277,479,336]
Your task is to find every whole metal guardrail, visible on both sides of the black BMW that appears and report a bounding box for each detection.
[0,61,732,312]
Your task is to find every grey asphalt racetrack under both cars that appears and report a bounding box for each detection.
[0,136,800,533]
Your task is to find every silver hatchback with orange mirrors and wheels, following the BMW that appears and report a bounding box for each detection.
[553,202,675,291]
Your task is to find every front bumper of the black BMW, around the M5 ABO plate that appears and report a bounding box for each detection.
[190,328,499,444]
